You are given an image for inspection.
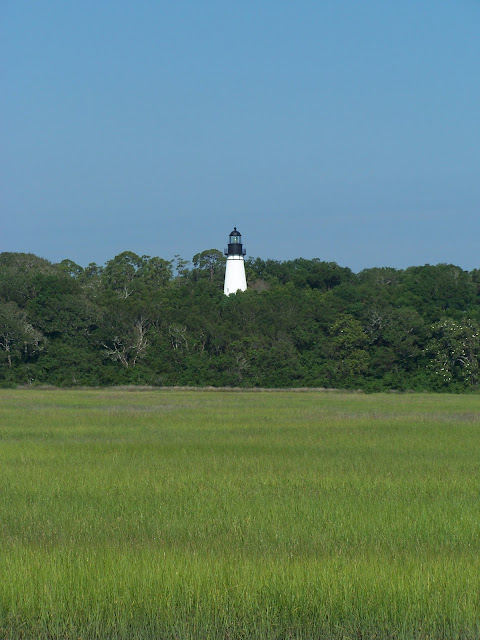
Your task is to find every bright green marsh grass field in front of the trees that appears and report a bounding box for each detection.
[0,390,480,640]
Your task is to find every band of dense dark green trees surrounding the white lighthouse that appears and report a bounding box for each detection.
[0,250,480,391]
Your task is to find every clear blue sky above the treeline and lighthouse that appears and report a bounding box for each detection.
[0,0,480,271]
